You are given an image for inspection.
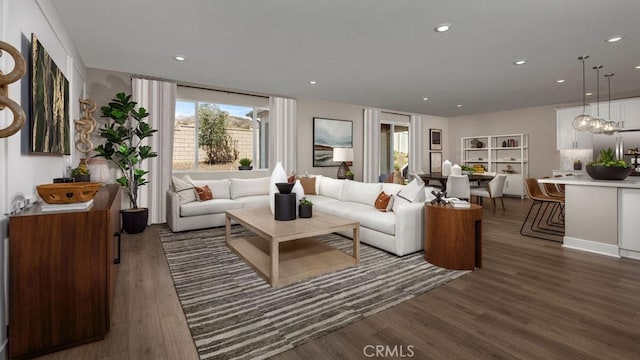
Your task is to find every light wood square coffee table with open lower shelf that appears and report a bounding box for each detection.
[225,208,360,287]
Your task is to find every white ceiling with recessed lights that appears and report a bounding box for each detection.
[50,0,640,117]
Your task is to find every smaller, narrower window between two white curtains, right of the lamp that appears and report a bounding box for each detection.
[380,113,409,179]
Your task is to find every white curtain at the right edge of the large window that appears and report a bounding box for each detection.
[269,97,298,175]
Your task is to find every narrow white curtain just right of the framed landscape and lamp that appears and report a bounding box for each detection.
[362,108,380,182]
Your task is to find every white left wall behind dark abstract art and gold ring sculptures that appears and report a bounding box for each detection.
[0,0,85,359]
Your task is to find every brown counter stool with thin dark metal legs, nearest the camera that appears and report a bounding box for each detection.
[520,178,564,240]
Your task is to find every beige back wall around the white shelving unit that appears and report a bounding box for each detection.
[443,105,560,178]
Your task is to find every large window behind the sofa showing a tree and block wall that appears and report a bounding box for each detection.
[173,87,269,171]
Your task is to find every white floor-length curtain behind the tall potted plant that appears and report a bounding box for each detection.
[131,78,176,224]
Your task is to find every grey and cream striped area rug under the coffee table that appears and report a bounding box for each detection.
[159,226,467,359]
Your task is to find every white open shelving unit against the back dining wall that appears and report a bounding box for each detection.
[460,134,529,198]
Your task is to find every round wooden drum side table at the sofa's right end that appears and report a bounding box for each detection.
[424,204,482,270]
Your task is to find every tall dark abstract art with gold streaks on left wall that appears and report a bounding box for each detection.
[30,34,71,155]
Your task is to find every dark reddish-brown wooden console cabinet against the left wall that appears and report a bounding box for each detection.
[8,185,120,359]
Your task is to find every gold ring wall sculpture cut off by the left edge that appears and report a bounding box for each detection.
[0,41,27,138]
